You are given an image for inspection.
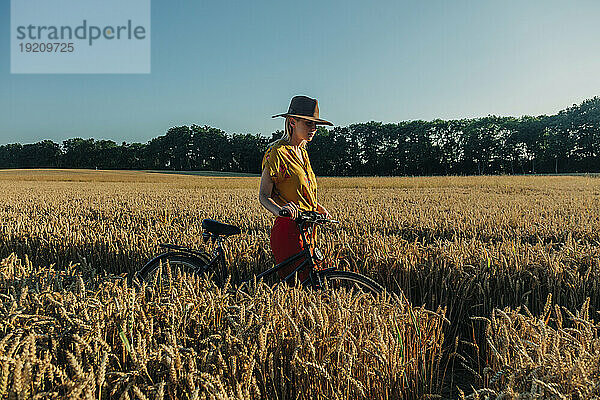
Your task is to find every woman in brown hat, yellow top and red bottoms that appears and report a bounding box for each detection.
[258,96,333,282]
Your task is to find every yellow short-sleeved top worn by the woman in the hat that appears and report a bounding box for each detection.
[262,139,317,211]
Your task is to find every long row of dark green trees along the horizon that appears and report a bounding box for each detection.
[0,97,600,176]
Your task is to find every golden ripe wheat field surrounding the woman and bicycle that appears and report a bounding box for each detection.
[0,170,600,399]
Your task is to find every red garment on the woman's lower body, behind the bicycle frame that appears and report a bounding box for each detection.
[271,217,311,282]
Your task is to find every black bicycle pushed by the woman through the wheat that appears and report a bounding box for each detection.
[136,210,384,295]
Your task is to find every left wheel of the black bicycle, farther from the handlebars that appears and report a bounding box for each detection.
[136,253,210,286]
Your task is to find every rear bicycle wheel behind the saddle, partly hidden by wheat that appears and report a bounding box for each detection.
[136,252,210,285]
